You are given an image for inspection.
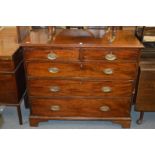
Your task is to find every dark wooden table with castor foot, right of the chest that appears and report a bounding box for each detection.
[135,59,155,124]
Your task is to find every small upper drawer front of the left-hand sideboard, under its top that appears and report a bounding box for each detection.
[0,60,15,72]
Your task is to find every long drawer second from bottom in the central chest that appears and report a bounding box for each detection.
[28,79,133,97]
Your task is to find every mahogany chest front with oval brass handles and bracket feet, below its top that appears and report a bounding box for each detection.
[24,46,140,128]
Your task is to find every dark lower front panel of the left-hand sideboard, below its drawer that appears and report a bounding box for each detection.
[0,74,17,104]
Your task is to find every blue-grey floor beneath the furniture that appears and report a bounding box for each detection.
[0,100,155,129]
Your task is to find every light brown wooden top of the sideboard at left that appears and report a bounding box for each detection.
[0,27,19,60]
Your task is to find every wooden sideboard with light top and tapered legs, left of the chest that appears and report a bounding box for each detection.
[0,28,27,124]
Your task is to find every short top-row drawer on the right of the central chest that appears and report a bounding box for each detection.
[81,48,139,61]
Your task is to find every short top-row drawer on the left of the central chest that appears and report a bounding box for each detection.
[25,48,79,61]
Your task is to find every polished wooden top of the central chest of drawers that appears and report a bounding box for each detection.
[21,29,143,48]
